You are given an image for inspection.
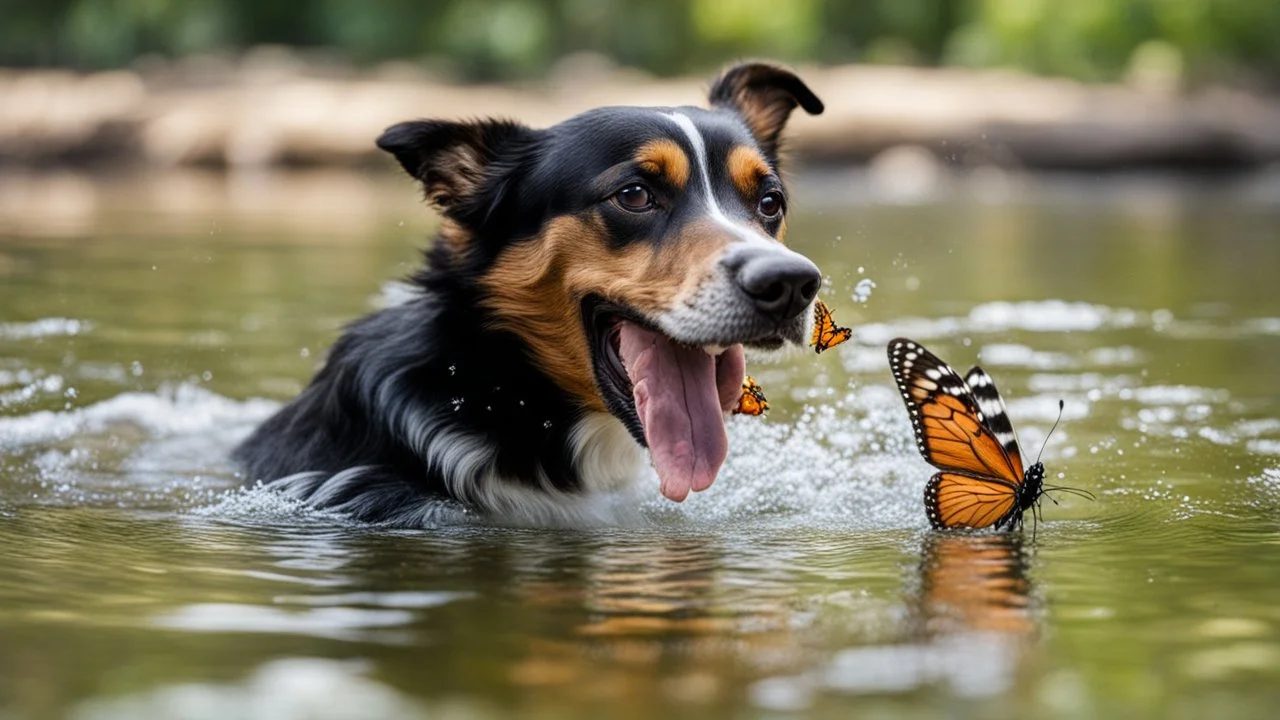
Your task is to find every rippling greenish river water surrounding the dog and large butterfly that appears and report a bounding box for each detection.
[0,166,1280,719]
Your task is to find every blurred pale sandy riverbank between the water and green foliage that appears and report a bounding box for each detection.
[0,53,1280,170]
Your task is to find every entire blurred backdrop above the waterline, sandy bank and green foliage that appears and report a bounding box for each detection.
[0,0,1280,175]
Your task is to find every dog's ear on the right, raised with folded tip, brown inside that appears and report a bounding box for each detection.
[710,63,823,159]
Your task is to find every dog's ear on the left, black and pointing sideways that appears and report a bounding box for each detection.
[378,120,534,214]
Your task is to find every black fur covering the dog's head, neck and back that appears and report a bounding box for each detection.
[234,60,820,524]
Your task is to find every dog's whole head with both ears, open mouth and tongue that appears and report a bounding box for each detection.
[379,64,822,500]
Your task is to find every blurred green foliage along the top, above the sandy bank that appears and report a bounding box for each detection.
[0,0,1280,81]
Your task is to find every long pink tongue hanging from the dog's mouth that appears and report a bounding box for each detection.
[618,322,746,502]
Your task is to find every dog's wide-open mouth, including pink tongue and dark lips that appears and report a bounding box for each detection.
[582,296,762,502]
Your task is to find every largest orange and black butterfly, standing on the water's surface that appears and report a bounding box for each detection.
[888,337,1093,530]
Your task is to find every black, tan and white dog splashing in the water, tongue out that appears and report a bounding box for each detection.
[233,63,823,527]
